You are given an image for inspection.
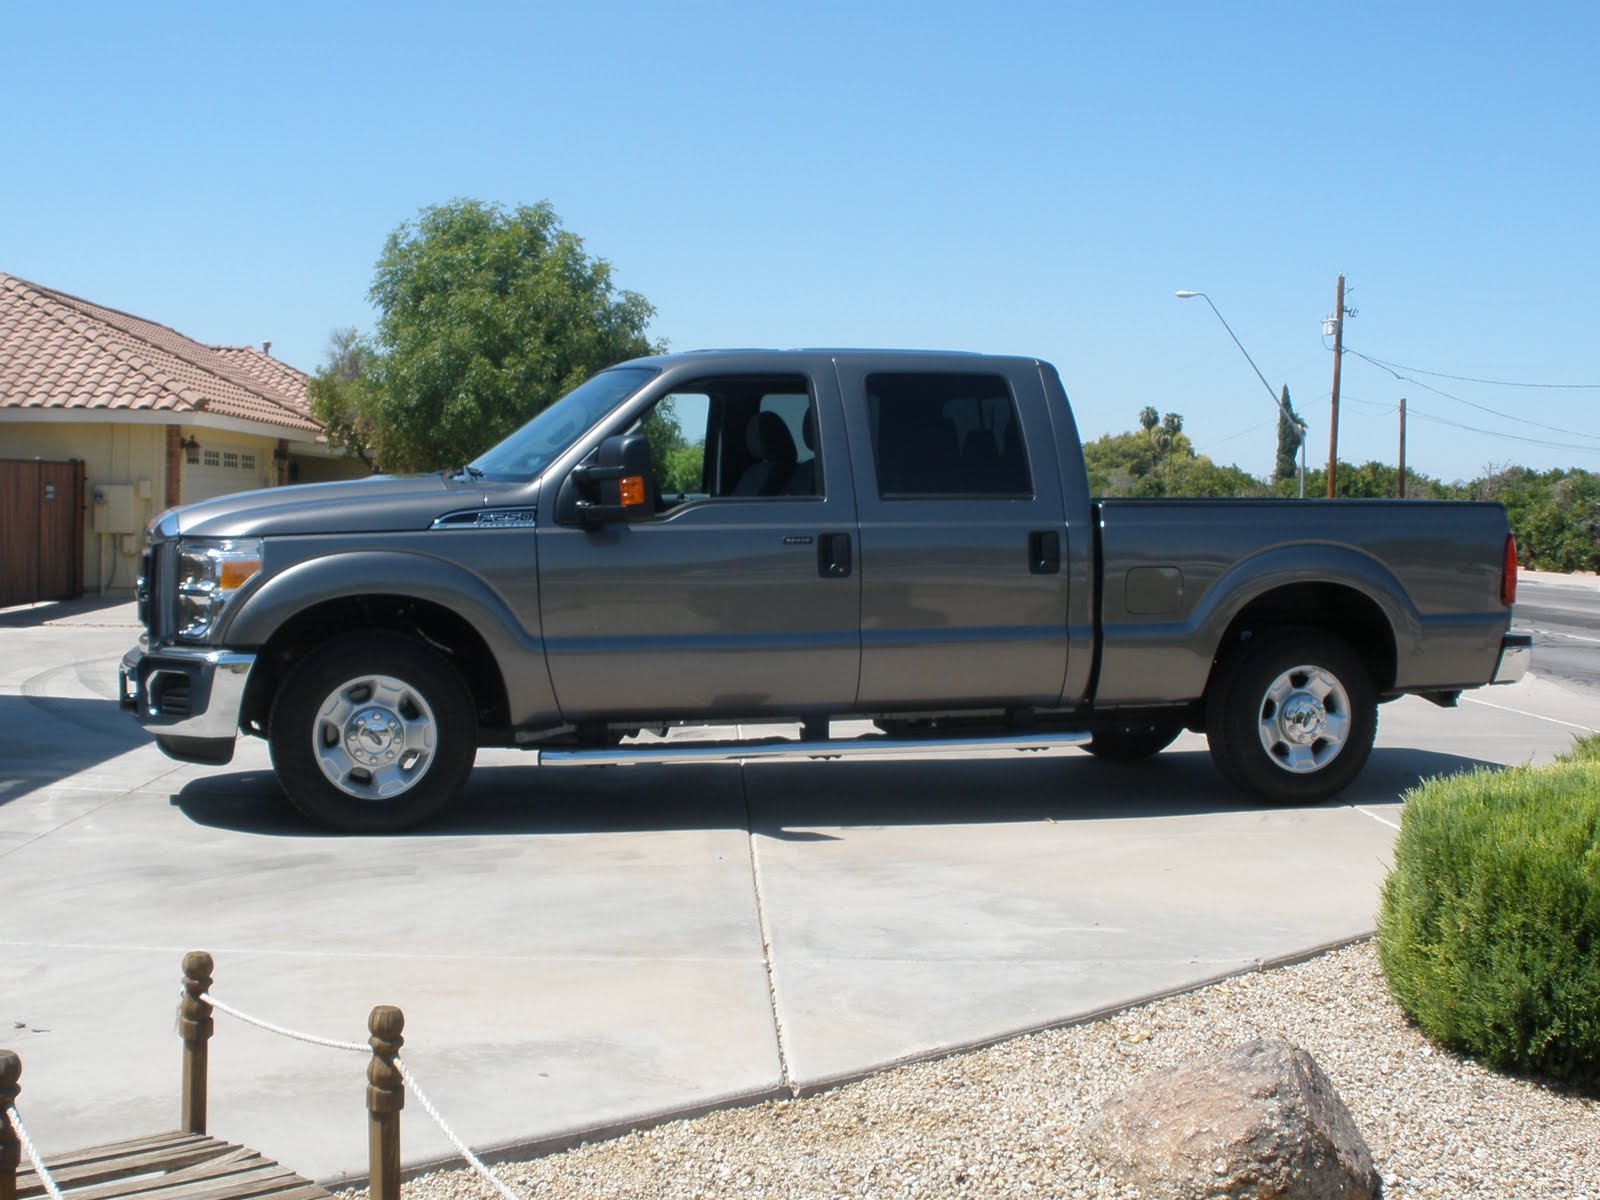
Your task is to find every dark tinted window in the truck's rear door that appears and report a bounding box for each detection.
[867,373,1034,499]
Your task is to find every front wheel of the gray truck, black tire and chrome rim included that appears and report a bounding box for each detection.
[267,634,477,834]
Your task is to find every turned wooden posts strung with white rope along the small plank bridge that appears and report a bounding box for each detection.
[0,950,523,1200]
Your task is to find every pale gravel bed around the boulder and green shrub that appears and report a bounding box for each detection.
[384,942,1600,1200]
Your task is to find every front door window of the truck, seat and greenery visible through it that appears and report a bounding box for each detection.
[634,376,822,510]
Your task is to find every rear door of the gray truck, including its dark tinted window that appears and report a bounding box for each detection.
[838,358,1067,709]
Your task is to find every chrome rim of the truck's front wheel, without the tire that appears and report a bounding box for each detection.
[310,675,438,800]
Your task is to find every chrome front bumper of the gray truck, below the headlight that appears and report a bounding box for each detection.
[117,638,256,741]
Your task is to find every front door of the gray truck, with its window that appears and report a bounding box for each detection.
[538,368,861,720]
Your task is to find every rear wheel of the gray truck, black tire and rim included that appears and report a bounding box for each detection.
[1205,629,1378,805]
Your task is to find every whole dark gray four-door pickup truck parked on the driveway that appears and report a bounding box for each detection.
[122,350,1531,832]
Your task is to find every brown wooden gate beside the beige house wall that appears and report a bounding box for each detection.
[0,459,83,608]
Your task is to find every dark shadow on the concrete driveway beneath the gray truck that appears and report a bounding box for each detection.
[171,749,1498,842]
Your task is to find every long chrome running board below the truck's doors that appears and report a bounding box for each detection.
[536,733,1090,766]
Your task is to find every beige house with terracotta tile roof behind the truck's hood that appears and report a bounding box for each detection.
[0,272,366,605]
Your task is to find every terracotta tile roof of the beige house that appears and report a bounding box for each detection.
[0,272,322,432]
